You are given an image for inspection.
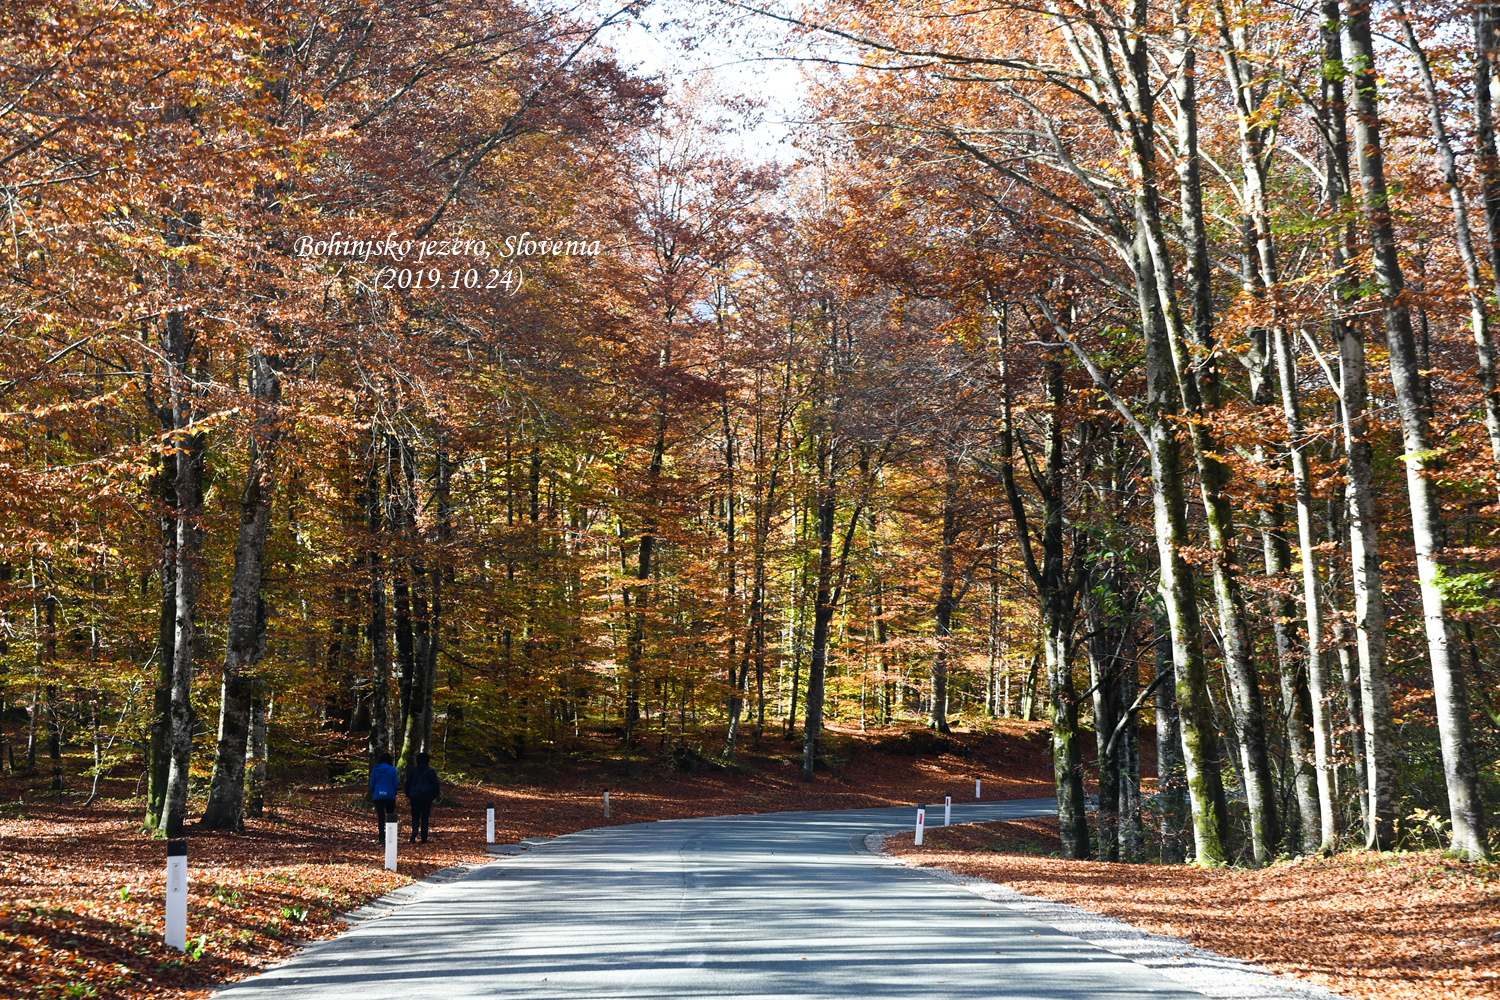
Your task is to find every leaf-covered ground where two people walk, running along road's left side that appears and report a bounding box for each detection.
[0,721,1053,1000]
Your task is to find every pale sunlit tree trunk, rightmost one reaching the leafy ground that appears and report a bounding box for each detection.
[1346,0,1490,859]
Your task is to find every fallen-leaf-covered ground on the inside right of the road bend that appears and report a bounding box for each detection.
[885,819,1500,1000]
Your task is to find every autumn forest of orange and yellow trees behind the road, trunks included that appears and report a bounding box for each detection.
[0,0,1500,864]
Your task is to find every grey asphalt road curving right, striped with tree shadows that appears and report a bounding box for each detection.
[219,799,1203,1000]
